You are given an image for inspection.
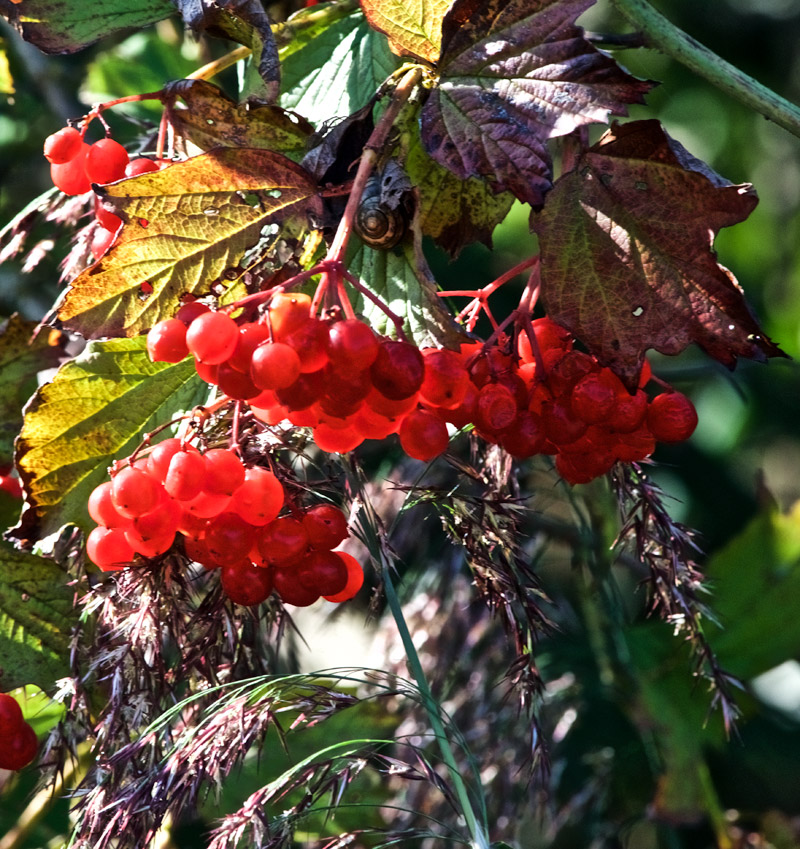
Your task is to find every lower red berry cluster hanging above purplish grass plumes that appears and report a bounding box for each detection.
[86,438,364,606]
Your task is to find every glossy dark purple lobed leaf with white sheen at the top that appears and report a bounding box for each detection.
[420,0,652,207]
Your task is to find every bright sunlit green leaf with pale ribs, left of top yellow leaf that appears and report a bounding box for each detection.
[281,12,399,124]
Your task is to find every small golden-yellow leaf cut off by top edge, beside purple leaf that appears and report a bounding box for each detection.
[361,0,452,62]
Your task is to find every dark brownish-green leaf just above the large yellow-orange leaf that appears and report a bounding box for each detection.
[170,80,314,160]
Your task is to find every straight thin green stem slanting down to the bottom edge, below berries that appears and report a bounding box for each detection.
[381,554,489,849]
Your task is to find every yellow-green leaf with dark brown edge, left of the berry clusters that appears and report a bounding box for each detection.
[14,337,209,540]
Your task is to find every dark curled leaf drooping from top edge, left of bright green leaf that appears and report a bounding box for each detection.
[172,0,281,103]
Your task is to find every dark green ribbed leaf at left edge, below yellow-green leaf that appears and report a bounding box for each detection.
[0,542,75,692]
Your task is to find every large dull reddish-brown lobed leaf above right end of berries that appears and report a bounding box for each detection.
[532,121,783,385]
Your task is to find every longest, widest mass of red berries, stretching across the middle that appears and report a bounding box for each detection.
[147,293,697,483]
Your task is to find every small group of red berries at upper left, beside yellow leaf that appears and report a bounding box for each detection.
[44,127,169,259]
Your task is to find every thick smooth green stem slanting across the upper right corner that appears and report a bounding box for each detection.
[613,0,800,137]
